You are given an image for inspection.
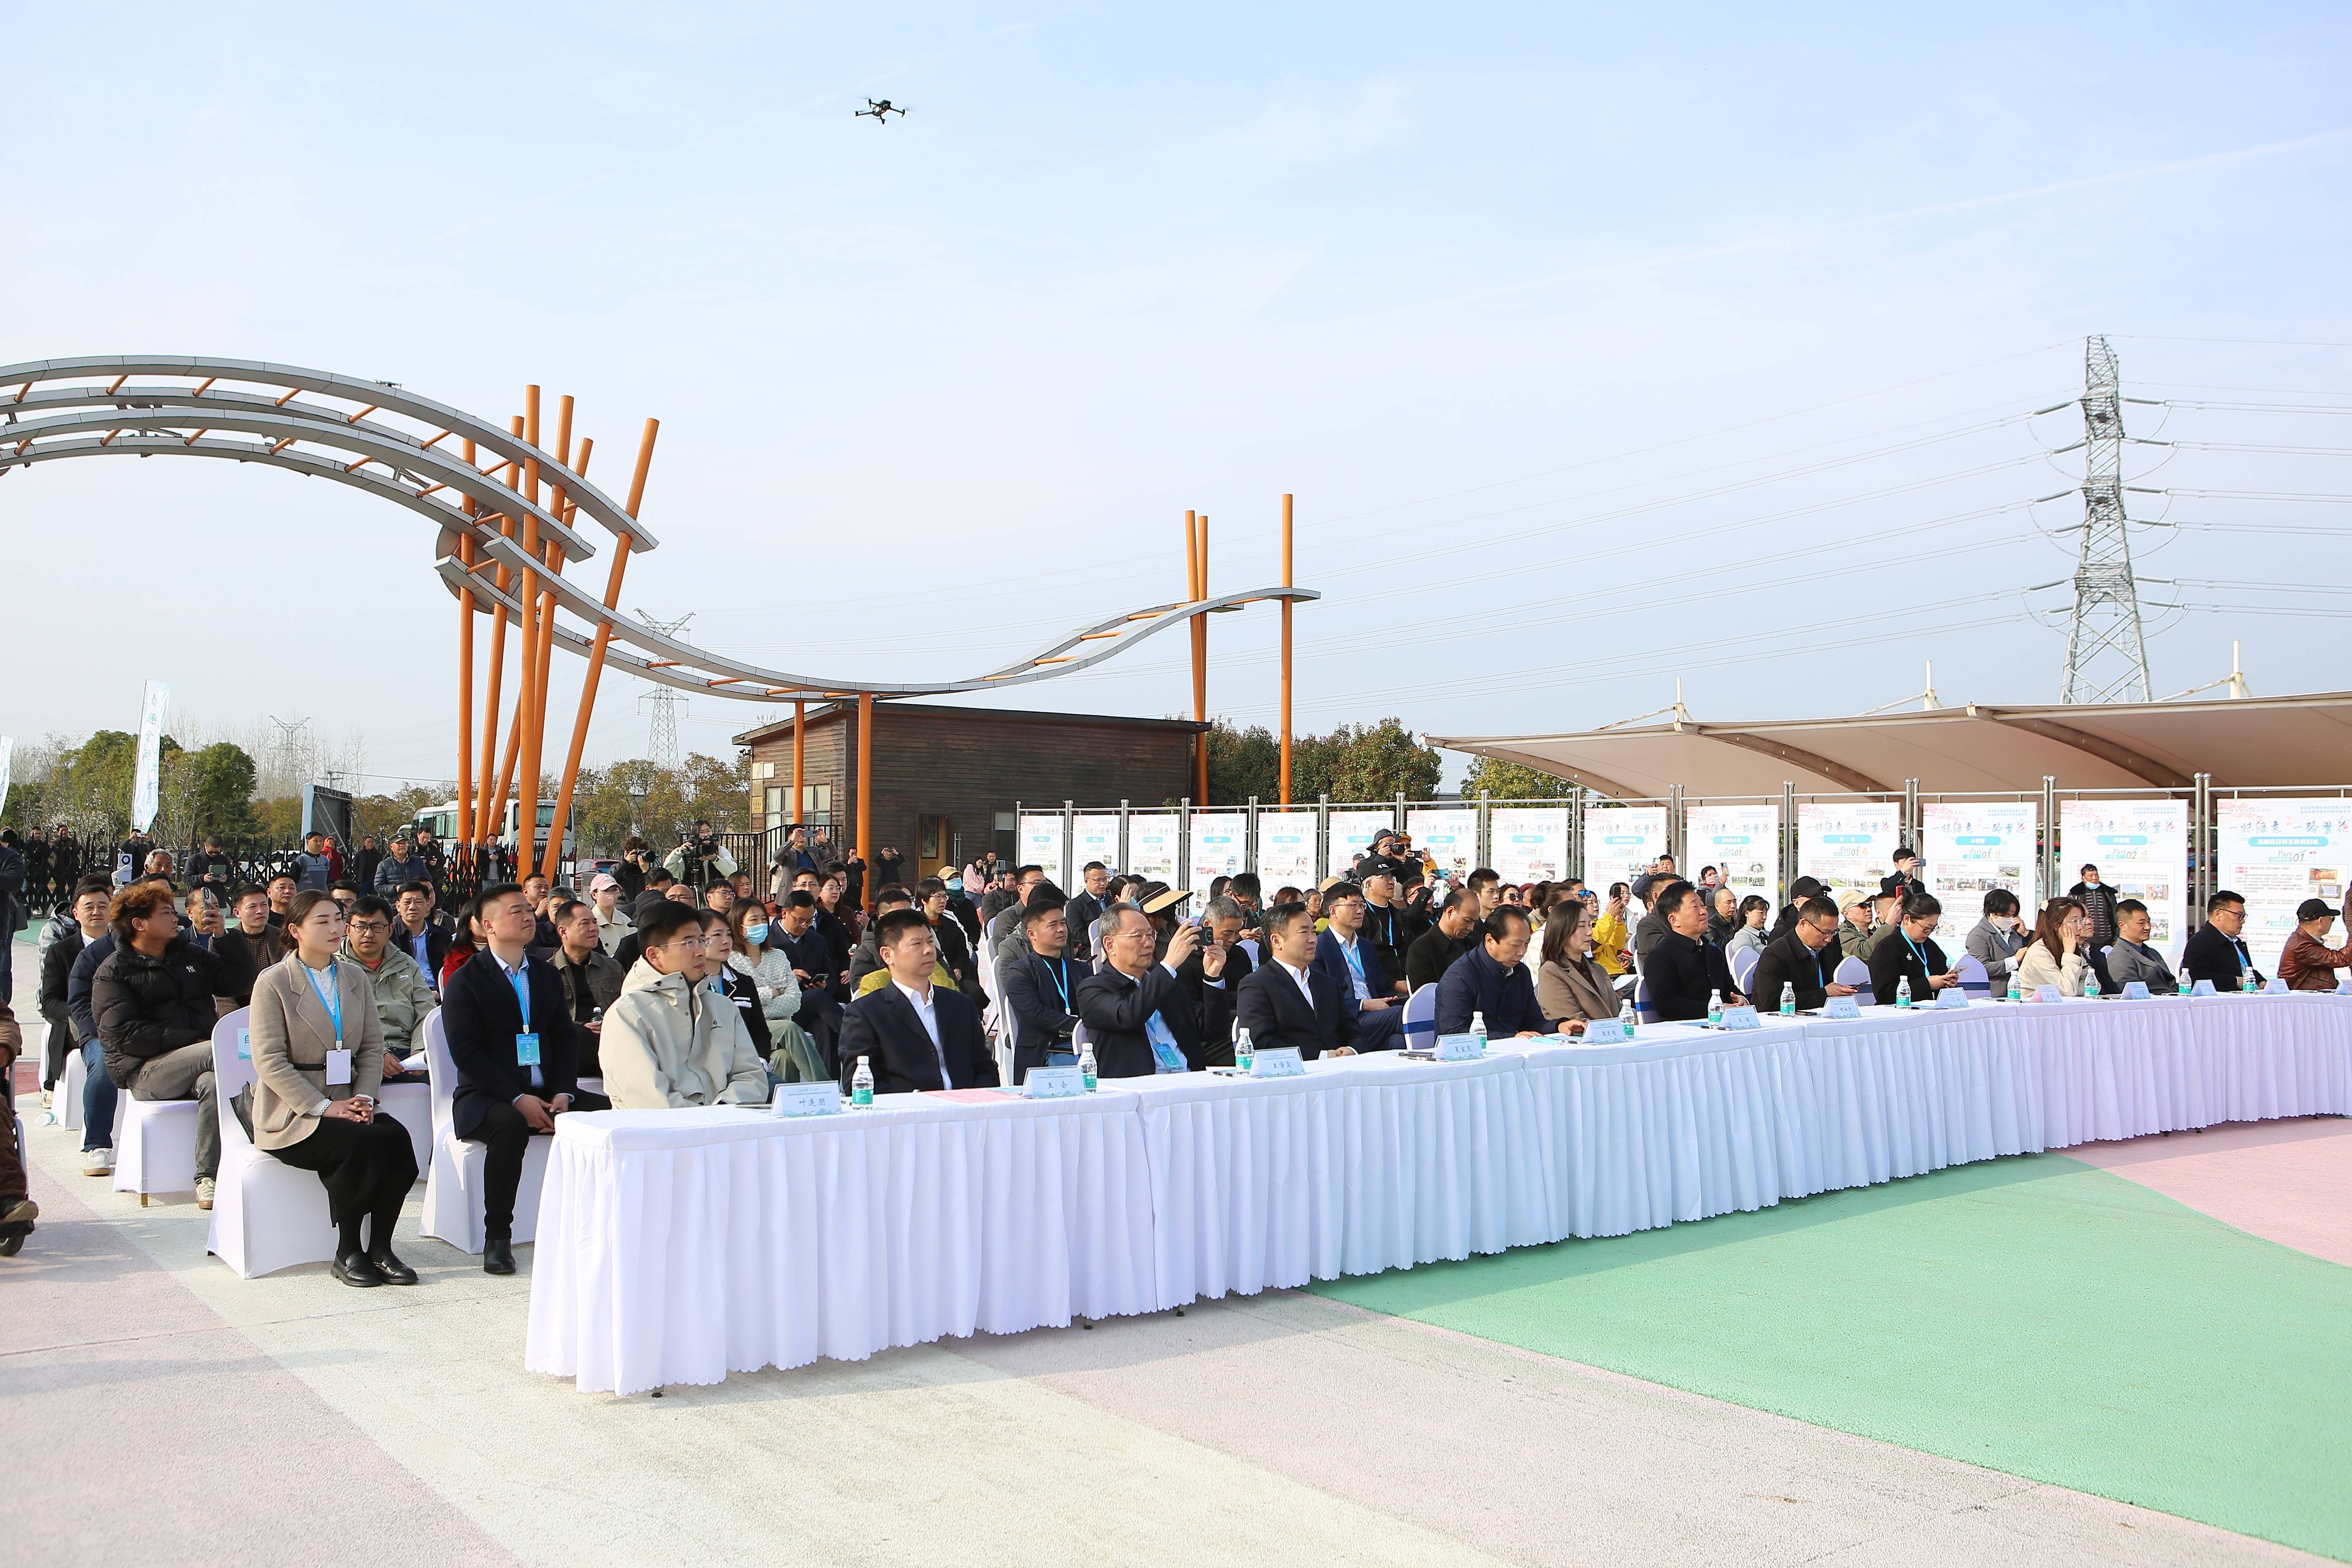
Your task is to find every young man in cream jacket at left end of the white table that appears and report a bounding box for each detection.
[597,900,767,1109]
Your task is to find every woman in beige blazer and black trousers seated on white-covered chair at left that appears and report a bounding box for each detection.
[247,889,416,1288]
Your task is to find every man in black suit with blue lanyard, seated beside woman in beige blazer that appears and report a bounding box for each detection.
[442,882,612,1274]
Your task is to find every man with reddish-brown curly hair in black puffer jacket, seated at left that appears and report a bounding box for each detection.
[89,882,221,1208]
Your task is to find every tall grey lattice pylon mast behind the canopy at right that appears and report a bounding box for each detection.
[2058,336,2150,703]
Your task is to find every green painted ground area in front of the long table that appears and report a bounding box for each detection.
[1315,1154,2352,1561]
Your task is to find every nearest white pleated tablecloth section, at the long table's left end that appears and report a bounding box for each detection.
[524,1093,1157,1394]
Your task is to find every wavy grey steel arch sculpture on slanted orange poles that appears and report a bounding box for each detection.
[0,355,1319,875]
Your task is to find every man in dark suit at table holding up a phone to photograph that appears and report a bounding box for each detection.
[1077,905,1232,1079]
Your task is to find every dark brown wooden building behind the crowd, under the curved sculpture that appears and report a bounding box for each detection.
[734,703,1207,877]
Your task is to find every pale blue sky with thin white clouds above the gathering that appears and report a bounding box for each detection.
[0,5,2352,776]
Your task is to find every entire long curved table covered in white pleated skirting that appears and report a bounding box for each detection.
[524,992,2352,1394]
